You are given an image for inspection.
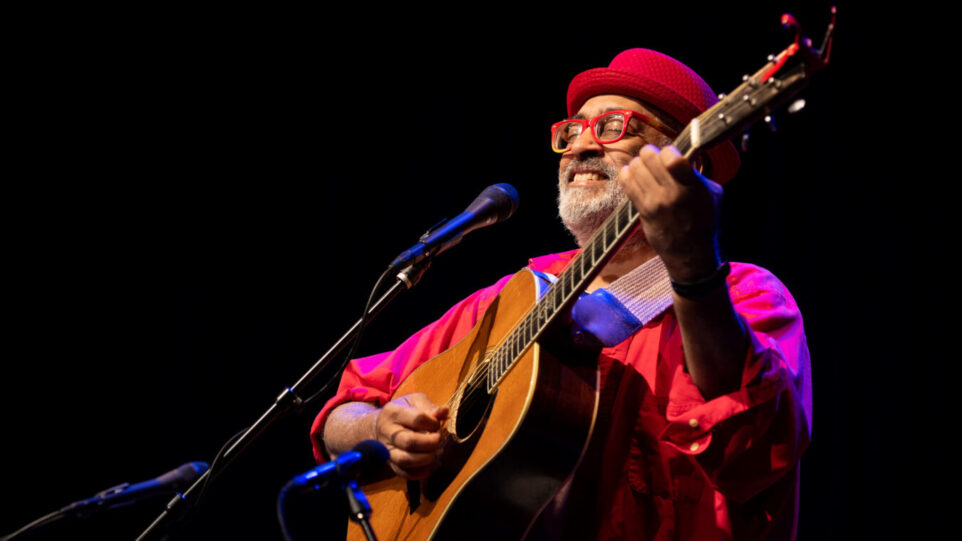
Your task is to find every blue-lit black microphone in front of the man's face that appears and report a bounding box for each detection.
[389,184,518,268]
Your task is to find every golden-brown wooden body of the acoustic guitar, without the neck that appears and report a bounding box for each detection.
[348,270,598,541]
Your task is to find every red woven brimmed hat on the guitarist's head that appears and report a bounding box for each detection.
[568,49,741,184]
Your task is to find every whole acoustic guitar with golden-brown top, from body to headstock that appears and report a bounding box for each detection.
[348,8,835,541]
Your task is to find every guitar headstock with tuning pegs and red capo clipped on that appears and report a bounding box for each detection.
[675,7,836,158]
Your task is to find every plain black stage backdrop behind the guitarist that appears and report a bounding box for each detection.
[0,6,936,539]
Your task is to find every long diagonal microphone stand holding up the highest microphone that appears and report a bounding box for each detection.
[137,258,431,541]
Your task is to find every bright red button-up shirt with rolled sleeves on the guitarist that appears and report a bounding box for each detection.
[311,252,812,541]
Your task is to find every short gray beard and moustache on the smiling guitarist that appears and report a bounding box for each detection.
[558,158,628,248]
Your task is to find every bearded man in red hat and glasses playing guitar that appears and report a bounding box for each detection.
[312,49,811,540]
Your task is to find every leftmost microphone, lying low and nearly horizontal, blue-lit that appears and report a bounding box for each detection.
[60,462,210,518]
